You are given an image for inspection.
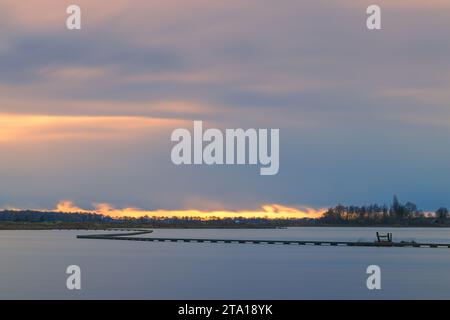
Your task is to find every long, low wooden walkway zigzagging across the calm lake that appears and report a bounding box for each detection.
[77,230,450,249]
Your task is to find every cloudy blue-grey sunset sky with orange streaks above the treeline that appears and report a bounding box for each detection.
[0,0,450,217]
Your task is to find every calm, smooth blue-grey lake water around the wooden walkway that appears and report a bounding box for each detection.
[0,228,450,299]
